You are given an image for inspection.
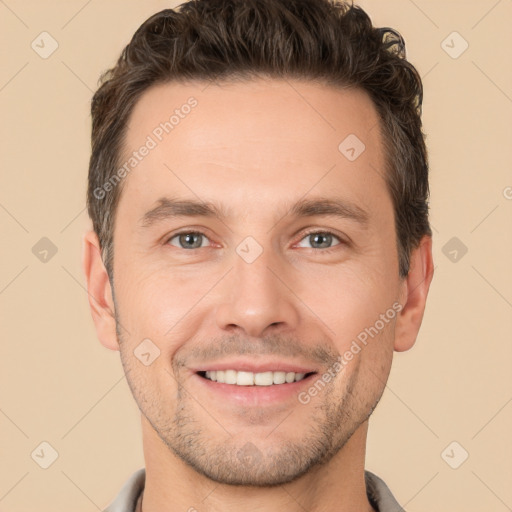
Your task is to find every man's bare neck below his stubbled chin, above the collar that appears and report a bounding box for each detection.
[138,416,374,512]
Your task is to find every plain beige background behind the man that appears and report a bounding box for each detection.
[0,0,512,512]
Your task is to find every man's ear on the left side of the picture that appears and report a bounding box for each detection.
[82,231,119,350]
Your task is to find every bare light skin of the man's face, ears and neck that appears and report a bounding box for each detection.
[83,79,433,512]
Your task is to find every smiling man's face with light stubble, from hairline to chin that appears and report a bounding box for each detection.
[114,80,403,485]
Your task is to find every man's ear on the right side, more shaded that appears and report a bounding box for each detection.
[394,235,434,352]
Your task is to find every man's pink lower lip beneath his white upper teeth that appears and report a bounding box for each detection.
[194,373,316,405]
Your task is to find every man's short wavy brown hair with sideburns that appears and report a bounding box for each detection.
[87,0,432,281]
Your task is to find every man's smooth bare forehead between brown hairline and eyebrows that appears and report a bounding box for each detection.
[121,79,385,222]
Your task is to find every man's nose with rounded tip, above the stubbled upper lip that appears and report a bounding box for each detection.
[216,251,300,337]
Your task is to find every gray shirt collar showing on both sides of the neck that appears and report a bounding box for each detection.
[103,468,405,512]
